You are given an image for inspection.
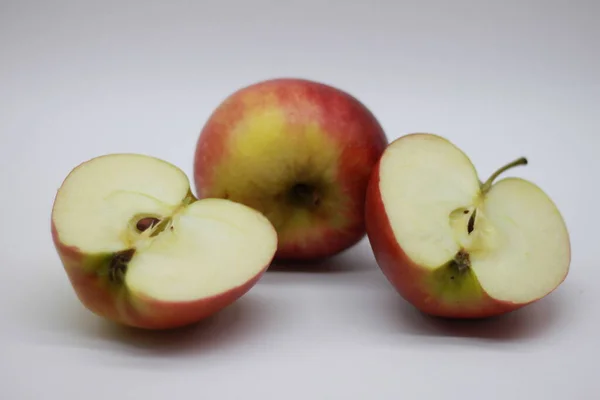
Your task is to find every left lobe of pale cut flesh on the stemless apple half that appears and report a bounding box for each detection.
[52,153,194,253]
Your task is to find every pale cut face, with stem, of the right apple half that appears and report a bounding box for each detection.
[379,134,570,303]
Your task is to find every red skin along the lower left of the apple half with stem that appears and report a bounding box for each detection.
[365,162,531,318]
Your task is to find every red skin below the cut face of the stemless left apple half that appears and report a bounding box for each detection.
[52,222,268,330]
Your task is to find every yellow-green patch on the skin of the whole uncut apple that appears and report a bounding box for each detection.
[207,104,346,241]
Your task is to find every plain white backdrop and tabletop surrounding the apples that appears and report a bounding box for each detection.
[0,0,600,400]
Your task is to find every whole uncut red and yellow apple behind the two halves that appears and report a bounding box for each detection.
[194,78,387,260]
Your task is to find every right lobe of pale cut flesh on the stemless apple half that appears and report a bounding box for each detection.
[125,198,277,302]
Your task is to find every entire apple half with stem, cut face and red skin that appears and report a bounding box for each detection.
[366,134,570,318]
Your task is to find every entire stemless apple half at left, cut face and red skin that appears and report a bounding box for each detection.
[52,154,277,329]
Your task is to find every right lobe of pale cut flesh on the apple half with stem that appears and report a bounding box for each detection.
[471,178,571,304]
